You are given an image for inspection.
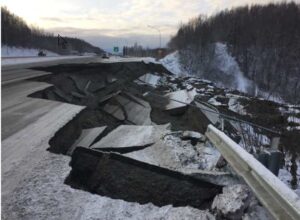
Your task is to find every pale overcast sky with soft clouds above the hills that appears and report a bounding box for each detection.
[1,0,300,50]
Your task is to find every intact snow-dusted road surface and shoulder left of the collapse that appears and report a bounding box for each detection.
[1,57,218,219]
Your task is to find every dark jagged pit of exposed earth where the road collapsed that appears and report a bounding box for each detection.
[30,62,222,209]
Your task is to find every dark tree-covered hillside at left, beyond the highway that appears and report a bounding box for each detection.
[1,7,103,54]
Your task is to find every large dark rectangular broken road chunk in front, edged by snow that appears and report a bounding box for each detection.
[66,147,222,209]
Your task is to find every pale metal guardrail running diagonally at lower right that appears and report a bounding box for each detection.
[206,125,300,220]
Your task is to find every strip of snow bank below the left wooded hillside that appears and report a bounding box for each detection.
[1,45,59,57]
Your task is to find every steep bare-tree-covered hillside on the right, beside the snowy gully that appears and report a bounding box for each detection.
[169,2,300,103]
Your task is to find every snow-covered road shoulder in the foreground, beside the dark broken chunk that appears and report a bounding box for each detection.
[2,152,215,220]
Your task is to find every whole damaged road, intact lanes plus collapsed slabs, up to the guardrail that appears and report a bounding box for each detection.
[2,55,300,219]
